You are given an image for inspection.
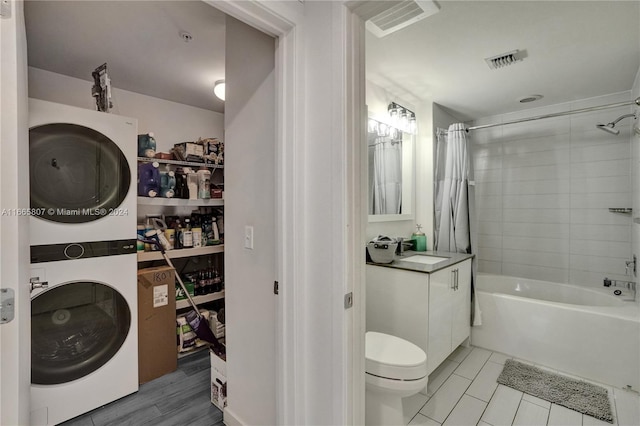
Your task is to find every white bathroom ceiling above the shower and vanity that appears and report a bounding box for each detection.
[366,1,640,120]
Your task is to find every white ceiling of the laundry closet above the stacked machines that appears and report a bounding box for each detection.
[25,0,225,112]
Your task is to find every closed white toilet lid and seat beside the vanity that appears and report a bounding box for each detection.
[365,331,427,380]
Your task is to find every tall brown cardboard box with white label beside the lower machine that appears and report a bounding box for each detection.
[138,266,178,384]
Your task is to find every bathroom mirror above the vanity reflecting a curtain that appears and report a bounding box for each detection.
[367,118,415,222]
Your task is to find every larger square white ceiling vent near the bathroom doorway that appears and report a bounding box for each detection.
[366,0,440,37]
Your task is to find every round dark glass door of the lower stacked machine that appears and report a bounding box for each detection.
[31,281,131,385]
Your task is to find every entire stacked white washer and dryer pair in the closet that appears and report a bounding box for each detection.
[29,99,138,425]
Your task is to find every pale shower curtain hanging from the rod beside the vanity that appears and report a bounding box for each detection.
[434,123,482,325]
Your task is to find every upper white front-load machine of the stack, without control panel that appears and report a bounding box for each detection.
[29,99,138,246]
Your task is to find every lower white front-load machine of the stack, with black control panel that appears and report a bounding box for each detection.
[31,243,138,425]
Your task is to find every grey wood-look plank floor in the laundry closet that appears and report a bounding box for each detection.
[62,350,223,426]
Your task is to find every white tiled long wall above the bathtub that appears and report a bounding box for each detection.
[470,92,640,286]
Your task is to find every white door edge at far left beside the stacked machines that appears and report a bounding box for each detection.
[0,0,31,425]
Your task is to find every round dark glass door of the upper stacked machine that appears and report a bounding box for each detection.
[29,123,131,223]
